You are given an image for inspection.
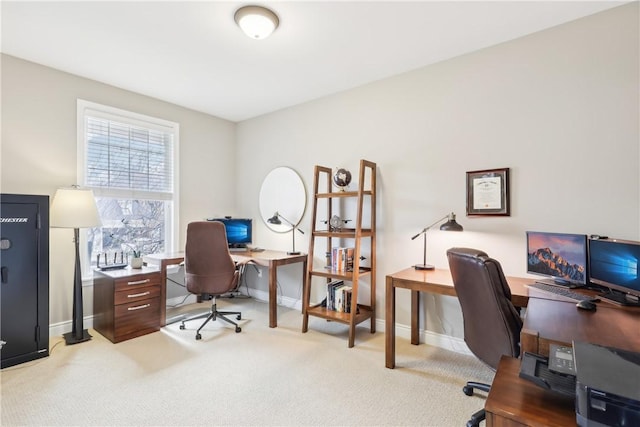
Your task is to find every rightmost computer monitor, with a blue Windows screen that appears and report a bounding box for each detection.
[589,239,640,305]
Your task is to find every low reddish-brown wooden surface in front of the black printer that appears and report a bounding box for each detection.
[484,356,576,427]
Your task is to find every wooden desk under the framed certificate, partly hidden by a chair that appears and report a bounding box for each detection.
[385,267,533,369]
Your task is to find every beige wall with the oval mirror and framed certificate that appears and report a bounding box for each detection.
[237,3,640,344]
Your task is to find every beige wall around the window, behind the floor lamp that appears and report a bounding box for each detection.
[0,55,236,324]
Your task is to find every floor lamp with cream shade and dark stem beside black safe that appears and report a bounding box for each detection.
[51,186,102,345]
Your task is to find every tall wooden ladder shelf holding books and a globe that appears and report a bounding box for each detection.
[302,159,376,347]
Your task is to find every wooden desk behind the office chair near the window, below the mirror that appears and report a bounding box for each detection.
[146,250,307,328]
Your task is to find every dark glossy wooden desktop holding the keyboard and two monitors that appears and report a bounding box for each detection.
[520,298,640,356]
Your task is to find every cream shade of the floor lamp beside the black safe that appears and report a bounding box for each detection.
[51,186,102,228]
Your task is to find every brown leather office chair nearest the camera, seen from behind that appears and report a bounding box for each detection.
[447,248,522,427]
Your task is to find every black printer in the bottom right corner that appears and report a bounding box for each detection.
[573,341,640,427]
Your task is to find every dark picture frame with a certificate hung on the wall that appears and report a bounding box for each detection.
[467,168,511,216]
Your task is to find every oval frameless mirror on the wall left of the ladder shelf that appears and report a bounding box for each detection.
[260,166,307,233]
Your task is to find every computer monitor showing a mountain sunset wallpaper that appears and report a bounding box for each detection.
[527,231,588,288]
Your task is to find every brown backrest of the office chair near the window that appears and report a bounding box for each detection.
[184,221,239,295]
